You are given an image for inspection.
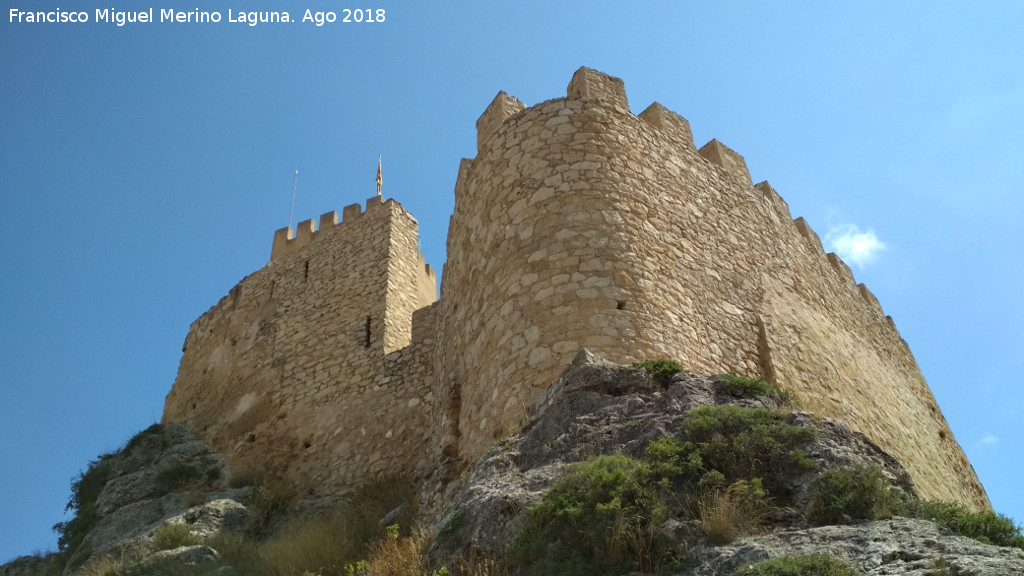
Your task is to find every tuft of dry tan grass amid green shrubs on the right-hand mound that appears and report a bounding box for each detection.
[697,481,773,544]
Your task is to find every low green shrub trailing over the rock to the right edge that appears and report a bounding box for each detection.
[895,500,1024,549]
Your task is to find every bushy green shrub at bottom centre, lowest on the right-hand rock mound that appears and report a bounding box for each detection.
[513,455,672,576]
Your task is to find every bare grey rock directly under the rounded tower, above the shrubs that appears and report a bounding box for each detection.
[435,349,913,557]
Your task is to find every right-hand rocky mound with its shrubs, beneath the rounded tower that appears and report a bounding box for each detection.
[431,351,1024,576]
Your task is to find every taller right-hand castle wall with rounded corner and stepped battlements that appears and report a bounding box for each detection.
[433,69,988,507]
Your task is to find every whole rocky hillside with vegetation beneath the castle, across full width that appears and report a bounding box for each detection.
[8,351,1024,576]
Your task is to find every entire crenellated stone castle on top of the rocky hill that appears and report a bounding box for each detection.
[163,68,989,508]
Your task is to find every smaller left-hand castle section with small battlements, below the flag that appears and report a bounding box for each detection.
[163,198,437,493]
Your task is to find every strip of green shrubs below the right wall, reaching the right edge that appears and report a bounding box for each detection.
[808,466,1024,549]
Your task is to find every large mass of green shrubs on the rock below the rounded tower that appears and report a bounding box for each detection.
[512,406,817,576]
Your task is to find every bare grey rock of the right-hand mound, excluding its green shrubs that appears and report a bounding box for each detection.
[430,351,1024,576]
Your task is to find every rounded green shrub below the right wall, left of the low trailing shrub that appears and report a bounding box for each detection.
[807,466,899,525]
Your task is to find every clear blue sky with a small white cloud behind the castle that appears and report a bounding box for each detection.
[0,0,1024,562]
